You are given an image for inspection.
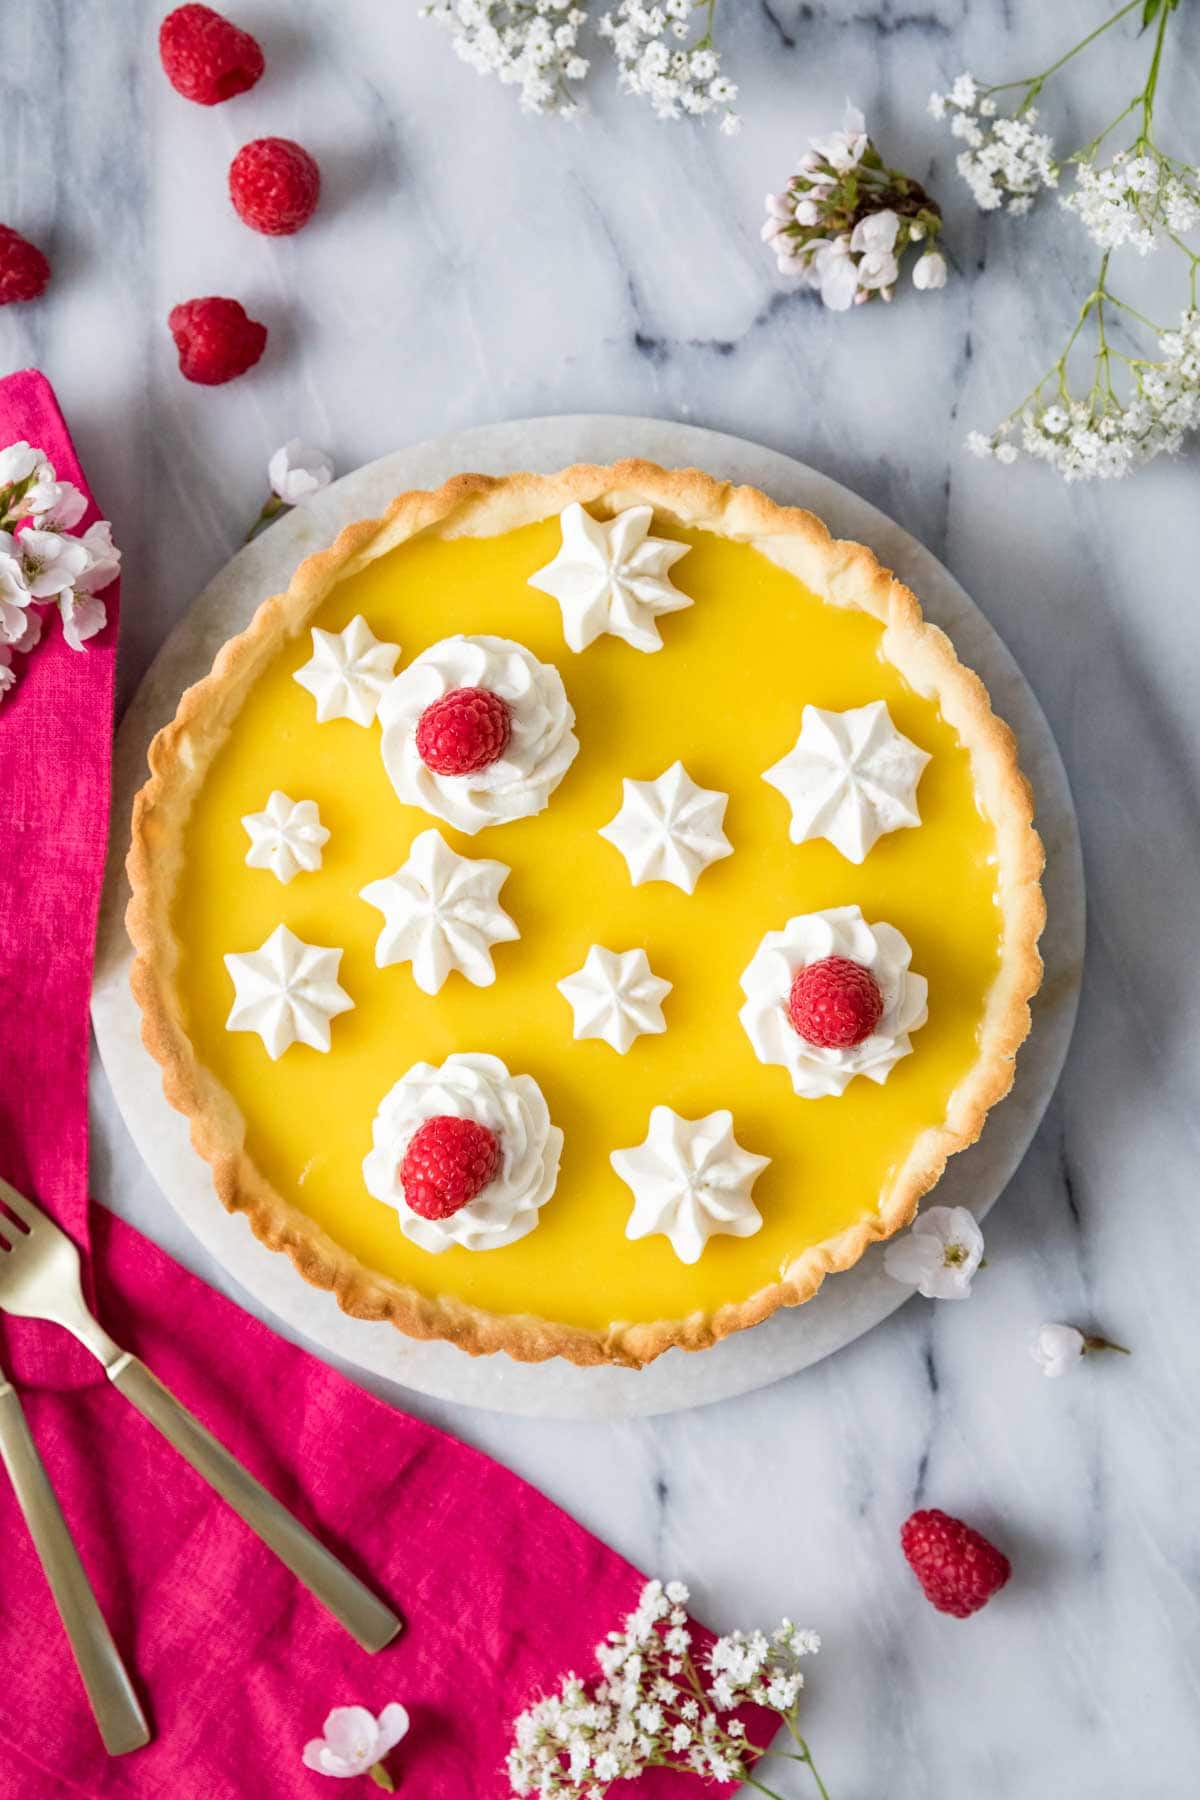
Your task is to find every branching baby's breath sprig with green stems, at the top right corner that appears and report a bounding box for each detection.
[930,0,1200,481]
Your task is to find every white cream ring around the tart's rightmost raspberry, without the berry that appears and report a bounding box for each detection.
[738,905,928,1100]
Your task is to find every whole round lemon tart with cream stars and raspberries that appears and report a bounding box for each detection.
[128,463,1043,1366]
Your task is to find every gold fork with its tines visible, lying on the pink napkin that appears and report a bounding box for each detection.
[0,1177,401,1651]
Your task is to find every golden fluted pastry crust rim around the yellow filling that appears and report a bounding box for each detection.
[126,461,1045,1366]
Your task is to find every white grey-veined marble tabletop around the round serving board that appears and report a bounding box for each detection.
[0,0,1200,1800]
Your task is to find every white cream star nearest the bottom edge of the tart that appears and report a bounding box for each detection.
[610,1107,770,1262]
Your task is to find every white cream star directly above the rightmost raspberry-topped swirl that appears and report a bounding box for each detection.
[763,700,930,862]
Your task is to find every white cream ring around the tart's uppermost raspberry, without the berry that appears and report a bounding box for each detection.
[380,635,579,833]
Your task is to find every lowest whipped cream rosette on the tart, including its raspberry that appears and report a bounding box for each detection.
[363,1053,563,1256]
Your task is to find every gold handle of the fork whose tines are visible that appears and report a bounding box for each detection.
[108,1352,401,1651]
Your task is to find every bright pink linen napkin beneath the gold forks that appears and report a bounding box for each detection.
[0,373,772,1800]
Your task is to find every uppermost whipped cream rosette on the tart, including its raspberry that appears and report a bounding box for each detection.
[380,635,579,833]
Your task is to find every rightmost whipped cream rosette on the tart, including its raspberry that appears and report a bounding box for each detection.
[738,905,928,1100]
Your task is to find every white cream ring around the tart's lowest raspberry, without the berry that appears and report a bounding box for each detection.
[363,1053,563,1256]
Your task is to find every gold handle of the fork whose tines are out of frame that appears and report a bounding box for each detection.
[0,1379,149,1757]
